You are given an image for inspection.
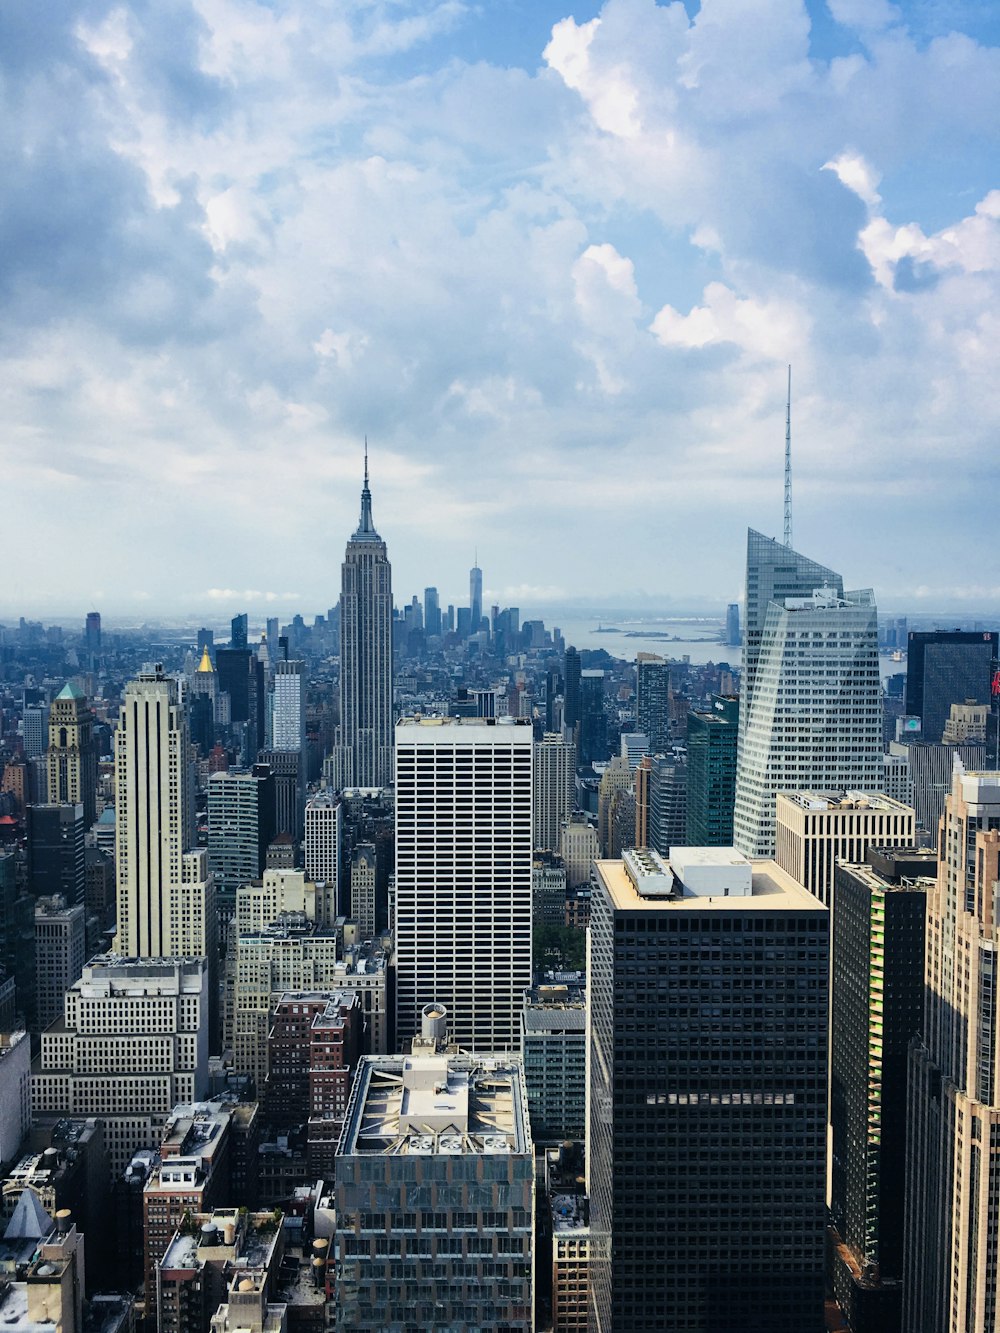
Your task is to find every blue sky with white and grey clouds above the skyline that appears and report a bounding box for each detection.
[0,0,1000,619]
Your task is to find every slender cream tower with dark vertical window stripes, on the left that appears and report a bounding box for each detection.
[115,665,217,966]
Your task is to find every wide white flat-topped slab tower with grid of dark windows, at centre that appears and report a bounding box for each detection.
[393,717,533,1052]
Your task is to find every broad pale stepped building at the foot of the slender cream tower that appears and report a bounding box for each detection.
[32,954,209,1177]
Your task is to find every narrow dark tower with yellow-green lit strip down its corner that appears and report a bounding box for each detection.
[831,846,937,1333]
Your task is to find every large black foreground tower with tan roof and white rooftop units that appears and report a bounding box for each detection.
[587,848,829,1333]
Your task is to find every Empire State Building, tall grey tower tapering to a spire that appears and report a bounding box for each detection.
[332,458,392,789]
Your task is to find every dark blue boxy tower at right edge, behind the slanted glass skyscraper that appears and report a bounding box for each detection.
[904,629,1000,745]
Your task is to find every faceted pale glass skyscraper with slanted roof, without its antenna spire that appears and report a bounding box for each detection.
[733,531,883,857]
